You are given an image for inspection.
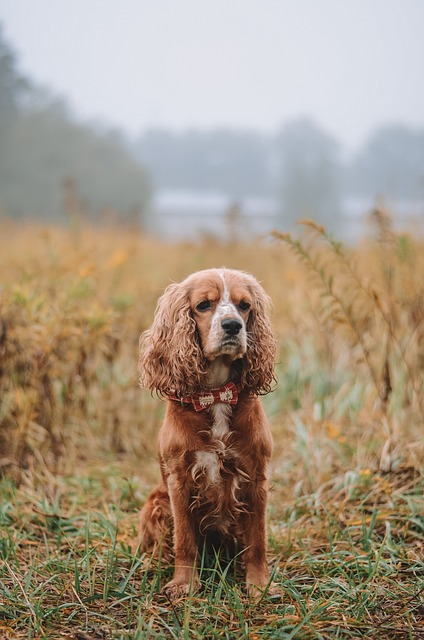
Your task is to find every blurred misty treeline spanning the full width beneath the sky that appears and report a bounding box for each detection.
[0,25,424,226]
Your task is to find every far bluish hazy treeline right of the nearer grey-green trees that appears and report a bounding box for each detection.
[134,119,424,229]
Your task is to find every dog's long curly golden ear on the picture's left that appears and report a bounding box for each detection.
[139,284,206,396]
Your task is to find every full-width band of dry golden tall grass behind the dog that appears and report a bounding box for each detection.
[0,211,424,480]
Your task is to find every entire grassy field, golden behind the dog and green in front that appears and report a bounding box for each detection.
[0,211,424,640]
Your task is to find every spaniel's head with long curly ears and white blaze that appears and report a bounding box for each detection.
[139,269,276,395]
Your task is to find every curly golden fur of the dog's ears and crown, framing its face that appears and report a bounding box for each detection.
[139,269,275,396]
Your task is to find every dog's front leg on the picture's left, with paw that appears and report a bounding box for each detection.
[163,473,198,599]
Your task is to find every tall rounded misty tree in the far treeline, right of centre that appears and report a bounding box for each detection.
[276,119,341,230]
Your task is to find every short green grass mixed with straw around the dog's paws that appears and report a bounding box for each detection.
[0,456,424,640]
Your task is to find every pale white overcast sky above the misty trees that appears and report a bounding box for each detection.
[0,0,424,149]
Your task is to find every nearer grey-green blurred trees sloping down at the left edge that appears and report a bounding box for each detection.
[0,25,150,222]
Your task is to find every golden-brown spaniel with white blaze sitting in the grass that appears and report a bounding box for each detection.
[139,268,276,599]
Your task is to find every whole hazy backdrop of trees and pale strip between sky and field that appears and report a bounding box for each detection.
[0,23,424,241]
